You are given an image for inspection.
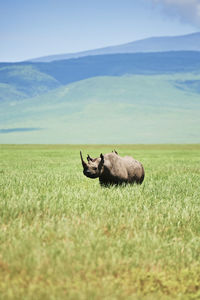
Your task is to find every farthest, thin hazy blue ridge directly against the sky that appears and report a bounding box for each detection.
[30,32,200,62]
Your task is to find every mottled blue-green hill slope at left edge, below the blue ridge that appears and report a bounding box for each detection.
[0,63,60,100]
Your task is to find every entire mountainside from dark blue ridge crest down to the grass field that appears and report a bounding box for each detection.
[0,51,200,143]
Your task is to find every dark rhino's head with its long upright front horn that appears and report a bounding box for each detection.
[80,151,104,178]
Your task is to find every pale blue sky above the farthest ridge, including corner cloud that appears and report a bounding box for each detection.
[0,0,200,62]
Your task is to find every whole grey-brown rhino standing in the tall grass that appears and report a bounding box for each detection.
[80,151,145,186]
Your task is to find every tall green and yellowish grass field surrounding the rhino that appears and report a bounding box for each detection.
[0,145,200,300]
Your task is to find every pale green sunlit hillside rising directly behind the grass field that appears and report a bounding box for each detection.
[0,73,200,143]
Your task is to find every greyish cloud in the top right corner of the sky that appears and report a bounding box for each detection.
[151,0,200,27]
